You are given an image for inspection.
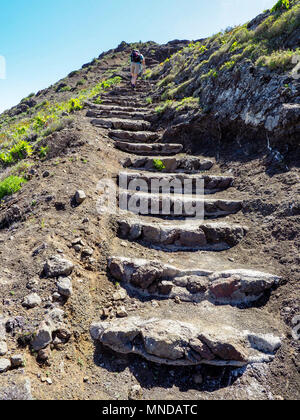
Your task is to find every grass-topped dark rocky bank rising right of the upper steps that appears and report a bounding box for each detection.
[151,1,300,161]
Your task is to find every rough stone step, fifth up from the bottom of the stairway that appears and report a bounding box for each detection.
[118,172,234,195]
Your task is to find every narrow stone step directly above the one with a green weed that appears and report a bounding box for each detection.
[115,141,183,156]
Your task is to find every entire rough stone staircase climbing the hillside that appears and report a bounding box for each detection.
[86,82,282,367]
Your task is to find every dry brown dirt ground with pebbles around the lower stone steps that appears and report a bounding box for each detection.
[0,83,300,400]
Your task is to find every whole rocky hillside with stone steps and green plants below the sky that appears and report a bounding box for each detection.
[0,1,300,400]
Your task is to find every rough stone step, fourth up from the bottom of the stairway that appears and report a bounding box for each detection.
[119,190,243,220]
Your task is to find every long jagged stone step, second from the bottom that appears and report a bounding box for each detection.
[108,257,280,306]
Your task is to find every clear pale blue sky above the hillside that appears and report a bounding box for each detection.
[0,0,275,112]
